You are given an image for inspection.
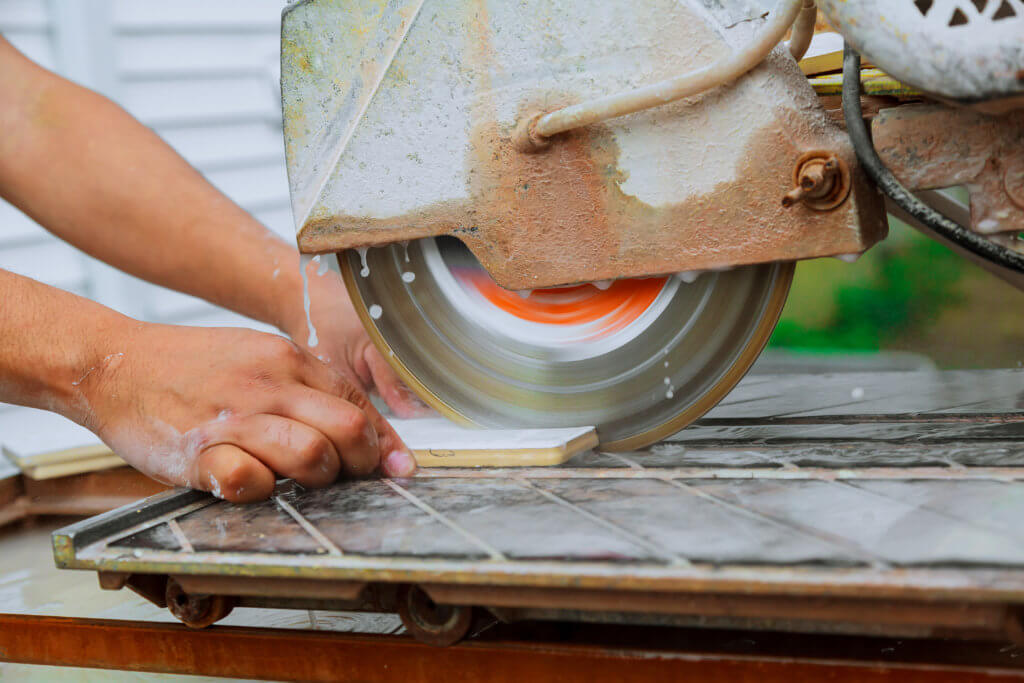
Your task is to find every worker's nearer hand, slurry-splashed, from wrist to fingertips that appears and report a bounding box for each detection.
[77,323,416,502]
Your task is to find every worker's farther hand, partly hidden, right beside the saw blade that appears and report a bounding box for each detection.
[283,255,429,418]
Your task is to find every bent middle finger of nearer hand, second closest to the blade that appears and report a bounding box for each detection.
[280,386,381,476]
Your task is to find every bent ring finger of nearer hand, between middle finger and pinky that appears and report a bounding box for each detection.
[204,415,341,488]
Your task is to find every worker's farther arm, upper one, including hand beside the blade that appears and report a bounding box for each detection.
[0,38,420,416]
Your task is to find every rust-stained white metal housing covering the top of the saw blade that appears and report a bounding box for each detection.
[282,0,886,289]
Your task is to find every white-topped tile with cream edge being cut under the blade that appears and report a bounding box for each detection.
[391,418,597,467]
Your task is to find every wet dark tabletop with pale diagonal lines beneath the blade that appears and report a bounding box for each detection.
[92,371,1024,570]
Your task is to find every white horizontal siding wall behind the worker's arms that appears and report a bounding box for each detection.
[0,0,293,326]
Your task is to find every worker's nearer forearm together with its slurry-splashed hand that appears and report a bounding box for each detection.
[0,270,415,502]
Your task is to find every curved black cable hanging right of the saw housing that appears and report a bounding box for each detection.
[843,45,1024,273]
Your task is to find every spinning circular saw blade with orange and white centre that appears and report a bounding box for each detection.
[339,238,794,451]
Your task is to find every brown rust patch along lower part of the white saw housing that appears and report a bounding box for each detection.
[300,107,888,289]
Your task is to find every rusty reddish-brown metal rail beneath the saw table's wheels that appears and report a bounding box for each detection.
[0,614,1024,683]
